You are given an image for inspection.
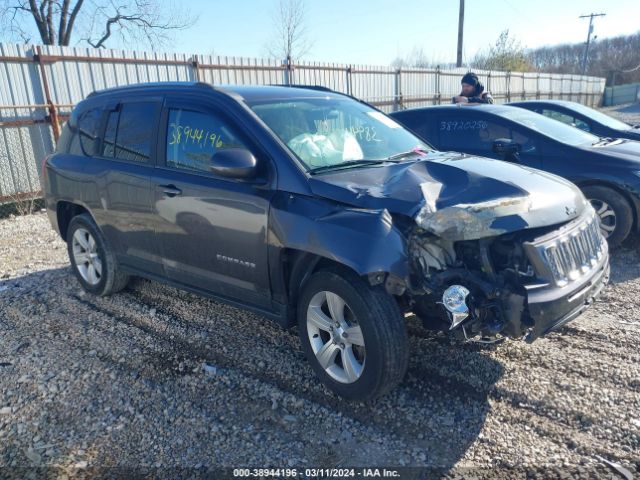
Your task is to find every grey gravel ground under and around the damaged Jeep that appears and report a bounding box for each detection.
[0,107,640,478]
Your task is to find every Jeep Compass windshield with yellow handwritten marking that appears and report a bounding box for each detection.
[249,97,433,171]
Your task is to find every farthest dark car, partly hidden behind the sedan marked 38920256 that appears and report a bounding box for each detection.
[509,100,640,140]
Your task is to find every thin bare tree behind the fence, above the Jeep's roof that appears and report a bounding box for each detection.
[267,0,313,60]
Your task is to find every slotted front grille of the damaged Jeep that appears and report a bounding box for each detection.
[530,209,607,287]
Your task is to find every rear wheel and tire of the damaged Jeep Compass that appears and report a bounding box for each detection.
[66,213,129,296]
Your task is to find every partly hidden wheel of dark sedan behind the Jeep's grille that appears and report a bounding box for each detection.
[582,185,633,248]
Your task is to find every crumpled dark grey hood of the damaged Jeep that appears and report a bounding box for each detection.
[309,152,587,241]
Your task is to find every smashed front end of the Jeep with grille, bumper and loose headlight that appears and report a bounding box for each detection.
[405,204,609,342]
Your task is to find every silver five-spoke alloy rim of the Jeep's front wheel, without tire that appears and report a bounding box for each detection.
[307,291,366,383]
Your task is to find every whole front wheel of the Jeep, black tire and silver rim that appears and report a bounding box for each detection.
[298,268,409,401]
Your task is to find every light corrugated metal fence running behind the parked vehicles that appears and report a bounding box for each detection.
[0,43,605,204]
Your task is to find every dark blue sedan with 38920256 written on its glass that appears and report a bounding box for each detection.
[391,105,640,247]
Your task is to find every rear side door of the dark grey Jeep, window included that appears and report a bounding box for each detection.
[81,97,162,274]
